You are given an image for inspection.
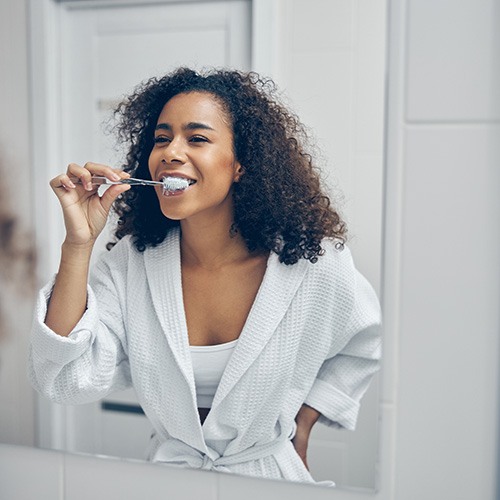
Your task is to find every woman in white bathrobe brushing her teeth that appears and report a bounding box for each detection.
[31,69,380,481]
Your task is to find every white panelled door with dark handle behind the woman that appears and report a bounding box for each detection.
[56,0,251,458]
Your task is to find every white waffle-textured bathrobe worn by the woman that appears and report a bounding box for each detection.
[29,230,381,481]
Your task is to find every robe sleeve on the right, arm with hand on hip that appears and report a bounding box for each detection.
[305,271,381,430]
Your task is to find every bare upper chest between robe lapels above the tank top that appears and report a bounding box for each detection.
[182,259,266,345]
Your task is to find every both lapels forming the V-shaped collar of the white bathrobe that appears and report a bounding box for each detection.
[144,229,308,428]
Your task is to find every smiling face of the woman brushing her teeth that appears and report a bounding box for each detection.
[149,92,240,220]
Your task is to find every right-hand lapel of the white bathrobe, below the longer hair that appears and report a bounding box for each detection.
[207,253,308,412]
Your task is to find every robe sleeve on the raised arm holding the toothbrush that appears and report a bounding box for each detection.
[28,246,131,404]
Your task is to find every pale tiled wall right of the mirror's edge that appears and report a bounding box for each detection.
[388,0,500,500]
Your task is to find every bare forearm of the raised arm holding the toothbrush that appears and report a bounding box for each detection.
[45,243,92,337]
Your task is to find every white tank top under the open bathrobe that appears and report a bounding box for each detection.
[189,339,238,408]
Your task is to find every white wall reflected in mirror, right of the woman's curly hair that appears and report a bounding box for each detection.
[266,0,387,291]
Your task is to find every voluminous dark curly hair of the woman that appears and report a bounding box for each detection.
[108,68,346,264]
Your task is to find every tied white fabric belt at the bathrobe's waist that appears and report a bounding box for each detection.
[152,434,290,472]
